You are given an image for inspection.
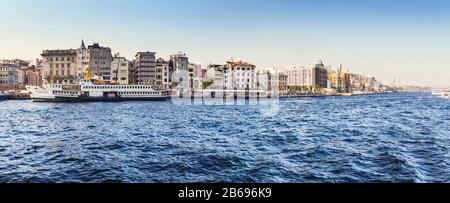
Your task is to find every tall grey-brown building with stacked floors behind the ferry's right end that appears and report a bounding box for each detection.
[133,51,156,85]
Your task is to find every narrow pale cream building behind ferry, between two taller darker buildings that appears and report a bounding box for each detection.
[110,54,129,85]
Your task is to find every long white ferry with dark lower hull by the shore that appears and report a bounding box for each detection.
[26,81,170,102]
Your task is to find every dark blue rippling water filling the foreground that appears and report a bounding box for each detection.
[0,94,450,183]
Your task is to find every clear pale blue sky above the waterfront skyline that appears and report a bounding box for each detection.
[0,0,450,87]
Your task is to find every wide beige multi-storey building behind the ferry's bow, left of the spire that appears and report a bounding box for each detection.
[41,49,78,84]
